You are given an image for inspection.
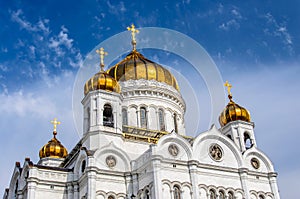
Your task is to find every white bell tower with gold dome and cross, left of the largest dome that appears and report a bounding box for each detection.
[82,48,122,134]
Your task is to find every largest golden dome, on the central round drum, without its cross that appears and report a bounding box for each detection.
[107,49,179,91]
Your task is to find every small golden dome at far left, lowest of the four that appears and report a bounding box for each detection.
[39,131,68,158]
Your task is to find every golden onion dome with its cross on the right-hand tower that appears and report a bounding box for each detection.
[219,81,251,127]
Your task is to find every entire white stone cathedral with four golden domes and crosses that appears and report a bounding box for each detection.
[3,25,280,199]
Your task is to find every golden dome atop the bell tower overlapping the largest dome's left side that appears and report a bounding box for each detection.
[84,71,120,95]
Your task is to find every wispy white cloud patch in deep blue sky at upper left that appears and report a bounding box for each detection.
[6,10,83,89]
